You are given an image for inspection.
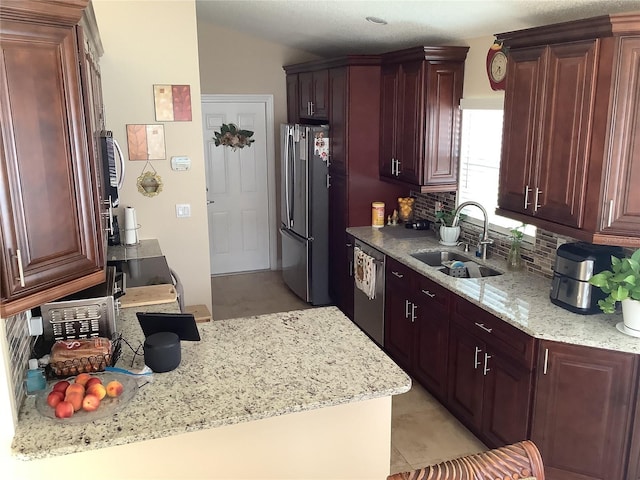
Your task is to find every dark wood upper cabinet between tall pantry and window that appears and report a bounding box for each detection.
[380,47,468,192]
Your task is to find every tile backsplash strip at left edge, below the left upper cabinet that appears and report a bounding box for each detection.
[2,312,36,407]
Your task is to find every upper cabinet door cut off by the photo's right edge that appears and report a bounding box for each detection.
[600,37,640,237]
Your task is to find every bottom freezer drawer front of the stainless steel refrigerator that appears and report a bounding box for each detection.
[280,228,311,302]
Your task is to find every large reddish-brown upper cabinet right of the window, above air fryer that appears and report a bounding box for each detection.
[497,14,640,247]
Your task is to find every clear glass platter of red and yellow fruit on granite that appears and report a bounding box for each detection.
[36,372,138,423]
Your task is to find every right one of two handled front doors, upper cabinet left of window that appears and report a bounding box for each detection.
[395,60,424,185]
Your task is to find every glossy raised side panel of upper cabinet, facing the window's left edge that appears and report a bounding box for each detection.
[418,62,464,185]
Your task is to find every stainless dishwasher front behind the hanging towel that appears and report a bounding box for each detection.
[353,240,385,347]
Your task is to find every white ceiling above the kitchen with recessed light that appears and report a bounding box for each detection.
[196,0,640,57]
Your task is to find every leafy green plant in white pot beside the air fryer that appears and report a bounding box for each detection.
[589,249,640,337]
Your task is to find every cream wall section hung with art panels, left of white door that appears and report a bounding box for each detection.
[93,0,211,309]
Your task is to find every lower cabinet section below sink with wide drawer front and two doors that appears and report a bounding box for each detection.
[446,298,534,448]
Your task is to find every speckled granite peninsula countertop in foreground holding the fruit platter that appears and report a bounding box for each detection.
[12,303,411,459]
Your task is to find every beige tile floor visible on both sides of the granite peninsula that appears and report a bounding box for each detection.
[211,271,487,473]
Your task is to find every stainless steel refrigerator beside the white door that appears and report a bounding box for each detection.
[280,124,331,305]
